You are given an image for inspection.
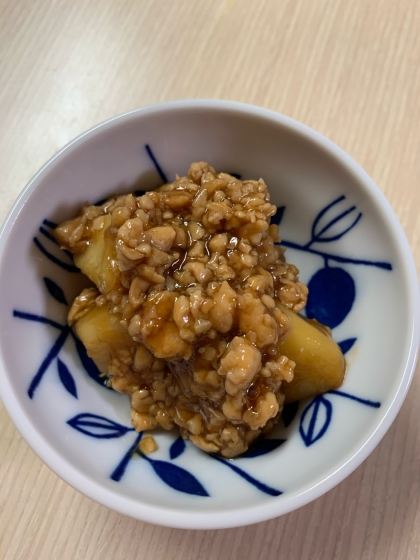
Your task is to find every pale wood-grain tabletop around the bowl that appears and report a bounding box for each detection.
[0,0,420,560]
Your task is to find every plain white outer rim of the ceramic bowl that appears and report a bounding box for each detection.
[0,99,420,529]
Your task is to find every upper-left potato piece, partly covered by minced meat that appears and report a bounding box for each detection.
[74,214,116,294]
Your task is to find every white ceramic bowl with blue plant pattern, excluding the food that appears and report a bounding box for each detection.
[0,101,420,528]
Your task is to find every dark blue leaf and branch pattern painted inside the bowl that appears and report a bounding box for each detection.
[13,145,392,497]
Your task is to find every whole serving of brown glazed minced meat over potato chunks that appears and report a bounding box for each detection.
[54,162,345,458]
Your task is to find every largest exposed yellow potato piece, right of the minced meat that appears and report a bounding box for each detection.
[276,302,345,403]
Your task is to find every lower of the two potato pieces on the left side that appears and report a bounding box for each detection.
[74,300,136,373]
